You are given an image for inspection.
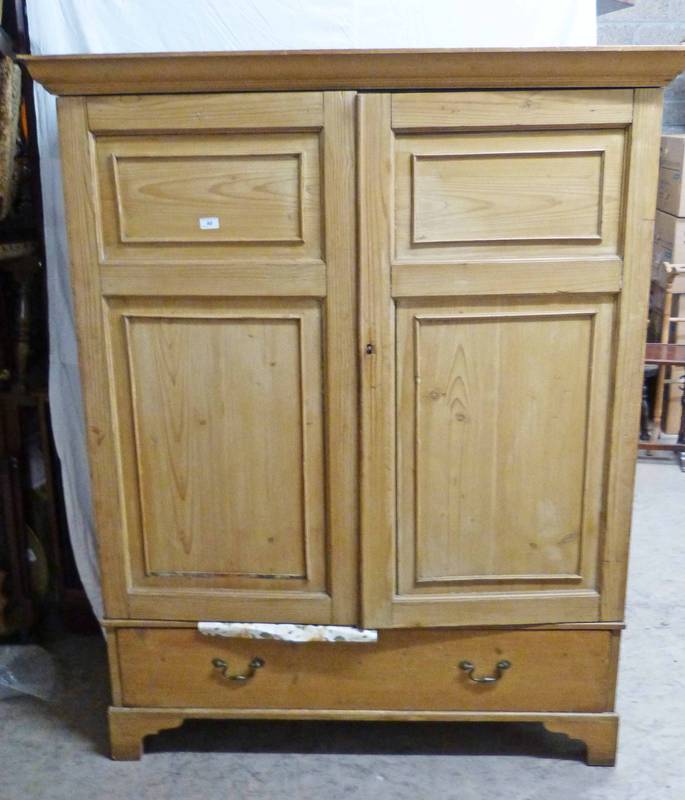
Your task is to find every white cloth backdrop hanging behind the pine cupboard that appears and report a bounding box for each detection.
[28,0,596,618]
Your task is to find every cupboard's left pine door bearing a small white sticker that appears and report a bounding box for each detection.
[59,92,357,623]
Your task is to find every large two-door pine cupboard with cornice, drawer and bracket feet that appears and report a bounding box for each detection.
[20,47,685,764]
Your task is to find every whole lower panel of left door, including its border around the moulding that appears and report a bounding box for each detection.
[110,300,326,592]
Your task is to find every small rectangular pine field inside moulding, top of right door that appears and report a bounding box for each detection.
[411,150,604,245]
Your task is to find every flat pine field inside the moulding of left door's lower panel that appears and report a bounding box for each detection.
[125,316,308,578]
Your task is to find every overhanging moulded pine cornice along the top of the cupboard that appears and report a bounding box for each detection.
[19,46,685,95]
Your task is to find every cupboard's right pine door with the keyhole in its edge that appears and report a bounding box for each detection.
[359,90,659,626]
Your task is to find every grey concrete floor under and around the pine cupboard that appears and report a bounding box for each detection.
[0,463,685,800]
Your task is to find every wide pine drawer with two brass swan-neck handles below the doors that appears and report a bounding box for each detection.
[117,628,618,711]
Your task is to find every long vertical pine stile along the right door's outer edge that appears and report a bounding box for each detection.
[601,89,663,620]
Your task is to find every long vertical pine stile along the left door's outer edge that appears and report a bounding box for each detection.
[57,97,128,617]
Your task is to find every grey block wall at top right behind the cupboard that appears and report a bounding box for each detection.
[597,0,685,131]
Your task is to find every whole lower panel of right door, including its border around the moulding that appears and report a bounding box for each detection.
[396,300,613,598]
